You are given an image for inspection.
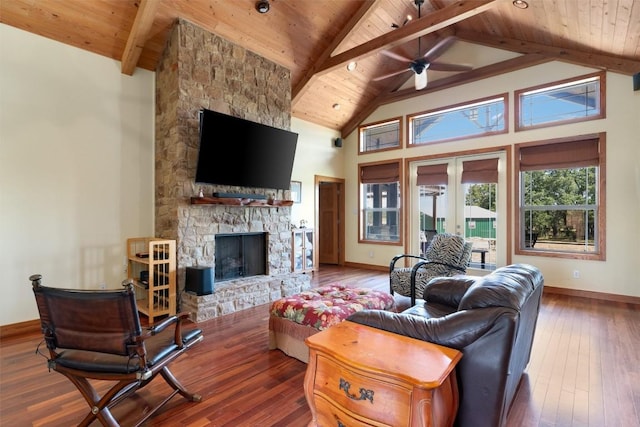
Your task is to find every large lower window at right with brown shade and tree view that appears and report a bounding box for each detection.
[516,134,605,260]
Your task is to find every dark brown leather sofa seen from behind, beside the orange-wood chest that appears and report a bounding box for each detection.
[348,264,544,427]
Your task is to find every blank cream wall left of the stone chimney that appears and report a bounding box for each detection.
[0,24,155,325]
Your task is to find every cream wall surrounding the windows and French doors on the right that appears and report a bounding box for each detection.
[345,62,640,296]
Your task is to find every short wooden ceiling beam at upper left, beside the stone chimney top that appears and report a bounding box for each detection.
[121,0,160,76]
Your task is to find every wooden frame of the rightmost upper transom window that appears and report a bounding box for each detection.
[513,71,607,132]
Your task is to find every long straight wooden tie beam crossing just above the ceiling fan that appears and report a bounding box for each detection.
[317,0,504,74]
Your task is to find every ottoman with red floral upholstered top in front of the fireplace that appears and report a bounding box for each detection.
[269,284,395,363]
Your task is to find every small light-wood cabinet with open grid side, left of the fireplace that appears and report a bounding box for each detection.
[127,237,177,323]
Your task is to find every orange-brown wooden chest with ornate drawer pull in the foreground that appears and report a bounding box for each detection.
[304,321,462,427]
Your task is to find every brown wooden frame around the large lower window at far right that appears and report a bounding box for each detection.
[514,132,607,261]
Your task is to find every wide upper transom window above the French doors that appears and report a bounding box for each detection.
[407,94,507,146]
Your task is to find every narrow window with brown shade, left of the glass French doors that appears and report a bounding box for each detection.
[359,161,401,244]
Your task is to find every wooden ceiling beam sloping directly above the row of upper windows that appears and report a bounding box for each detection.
[341,54,552,138]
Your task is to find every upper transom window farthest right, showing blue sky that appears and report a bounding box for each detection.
[515,73,606,131]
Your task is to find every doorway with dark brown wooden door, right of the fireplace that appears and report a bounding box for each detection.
[315,175,345,265]
